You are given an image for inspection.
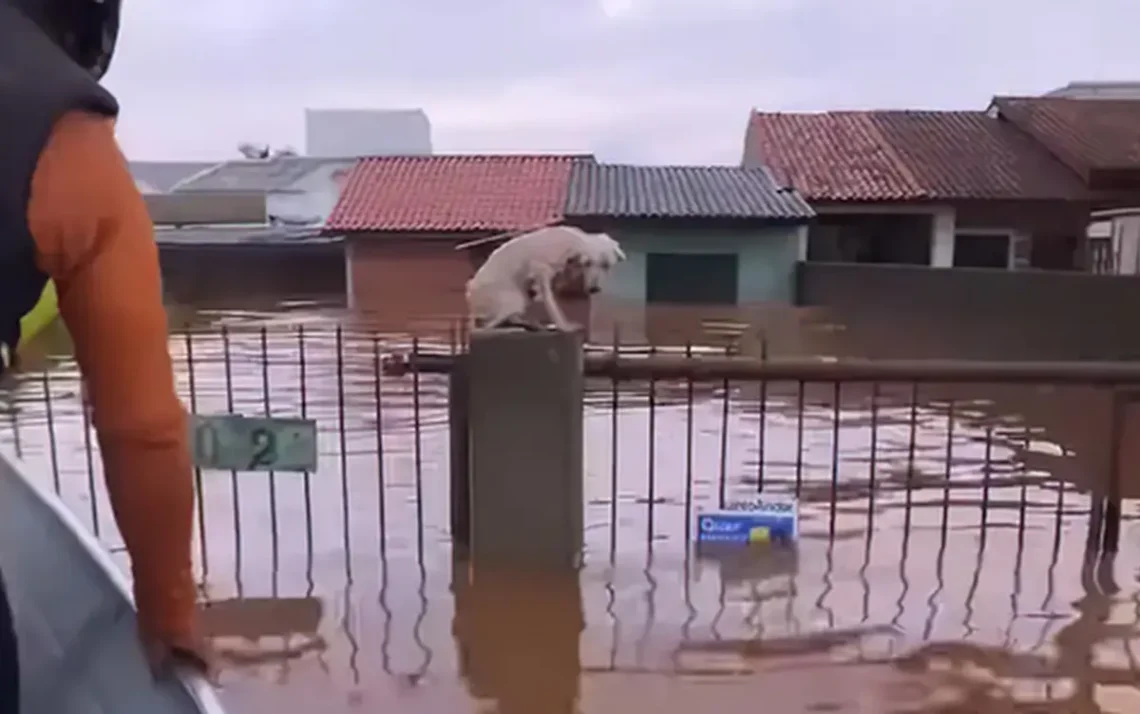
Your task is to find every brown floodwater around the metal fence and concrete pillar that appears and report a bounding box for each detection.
[0,290,1140,714]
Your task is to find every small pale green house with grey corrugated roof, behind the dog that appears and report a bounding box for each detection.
[565,161,814,343]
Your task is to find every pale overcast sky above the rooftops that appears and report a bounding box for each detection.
[106,0,1140,163]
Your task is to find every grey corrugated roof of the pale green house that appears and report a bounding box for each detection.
[565,162,815,220]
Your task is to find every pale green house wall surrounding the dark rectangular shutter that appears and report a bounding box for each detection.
[604,226,803,303]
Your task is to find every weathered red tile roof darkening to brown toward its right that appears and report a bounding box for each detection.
[744,111,1086,202]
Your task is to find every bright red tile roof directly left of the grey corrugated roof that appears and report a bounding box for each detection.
[326,154,592,233]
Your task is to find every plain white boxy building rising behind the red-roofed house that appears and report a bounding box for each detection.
[304,109,431,157]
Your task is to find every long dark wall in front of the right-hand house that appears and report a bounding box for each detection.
[798,262,1140,359]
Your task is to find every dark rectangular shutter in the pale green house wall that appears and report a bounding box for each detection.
[645,253,740,305]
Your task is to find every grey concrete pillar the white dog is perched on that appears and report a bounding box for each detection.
[466,330,583,568]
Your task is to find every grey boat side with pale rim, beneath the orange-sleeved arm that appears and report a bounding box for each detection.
[0,448,225,714]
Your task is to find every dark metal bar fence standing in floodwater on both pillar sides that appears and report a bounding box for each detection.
[6,327,1140,562]
